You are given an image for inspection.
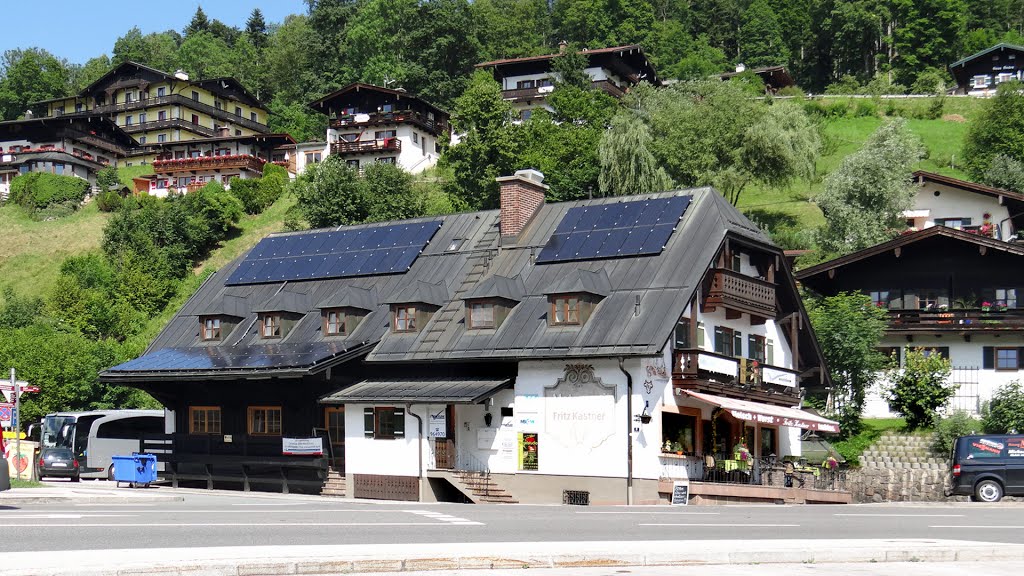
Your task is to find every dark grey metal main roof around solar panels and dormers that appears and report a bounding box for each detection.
[100,188,820,380]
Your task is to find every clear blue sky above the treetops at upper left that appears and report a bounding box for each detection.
[0,0,306,64]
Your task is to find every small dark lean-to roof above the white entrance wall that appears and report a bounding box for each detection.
[321,377,512,404]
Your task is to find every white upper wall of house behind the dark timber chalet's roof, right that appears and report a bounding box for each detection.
[913,182,1013,239]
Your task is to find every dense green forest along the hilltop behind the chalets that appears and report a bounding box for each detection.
[6,0,1024,139]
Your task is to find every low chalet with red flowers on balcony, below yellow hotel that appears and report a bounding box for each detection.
[141,134,295,198]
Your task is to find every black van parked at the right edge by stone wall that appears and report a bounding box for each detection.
[947,434,1024,502]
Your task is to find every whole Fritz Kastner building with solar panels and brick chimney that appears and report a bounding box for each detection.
[100,170,849,503]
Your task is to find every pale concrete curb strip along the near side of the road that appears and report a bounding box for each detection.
[5,539,1024,576]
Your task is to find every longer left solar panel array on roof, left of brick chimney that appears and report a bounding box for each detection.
[226,220,441,286]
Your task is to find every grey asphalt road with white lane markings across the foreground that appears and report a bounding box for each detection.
[0,483,1024,551]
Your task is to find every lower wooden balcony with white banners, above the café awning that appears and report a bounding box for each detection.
[672,349,800,406]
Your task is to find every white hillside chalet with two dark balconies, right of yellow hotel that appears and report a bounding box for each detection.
[302,83,449,173]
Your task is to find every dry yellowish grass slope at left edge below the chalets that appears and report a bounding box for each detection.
[0,202,110,299]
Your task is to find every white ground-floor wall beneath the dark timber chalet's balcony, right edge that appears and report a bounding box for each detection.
[863,334,1024,418]
